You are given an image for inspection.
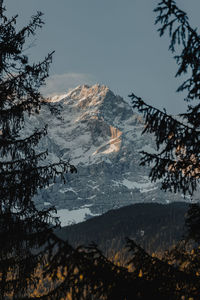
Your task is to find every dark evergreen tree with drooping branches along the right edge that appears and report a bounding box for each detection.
[130,0,200,195]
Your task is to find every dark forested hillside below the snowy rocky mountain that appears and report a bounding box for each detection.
[58,202,188,254]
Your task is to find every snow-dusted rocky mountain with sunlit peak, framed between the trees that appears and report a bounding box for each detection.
[27,85,183,219]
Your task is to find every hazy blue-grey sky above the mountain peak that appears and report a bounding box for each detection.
[4,0,200,113]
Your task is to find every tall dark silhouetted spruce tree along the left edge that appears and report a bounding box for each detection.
[0,1,76,299]
